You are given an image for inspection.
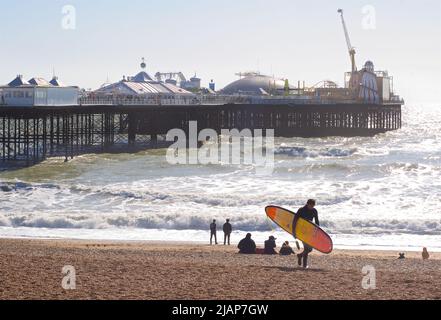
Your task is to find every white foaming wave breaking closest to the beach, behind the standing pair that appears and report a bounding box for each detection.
[0,212,441,235]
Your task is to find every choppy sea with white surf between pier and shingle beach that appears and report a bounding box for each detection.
[0,106,441,251]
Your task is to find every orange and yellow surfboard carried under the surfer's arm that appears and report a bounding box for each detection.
[265,206,333,254]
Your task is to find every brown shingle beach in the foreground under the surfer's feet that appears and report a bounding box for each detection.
[0,239,441,300]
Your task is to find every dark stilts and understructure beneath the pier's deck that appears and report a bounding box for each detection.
[0,104,401,165]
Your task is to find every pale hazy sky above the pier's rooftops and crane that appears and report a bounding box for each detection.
[0,0,441,107]
